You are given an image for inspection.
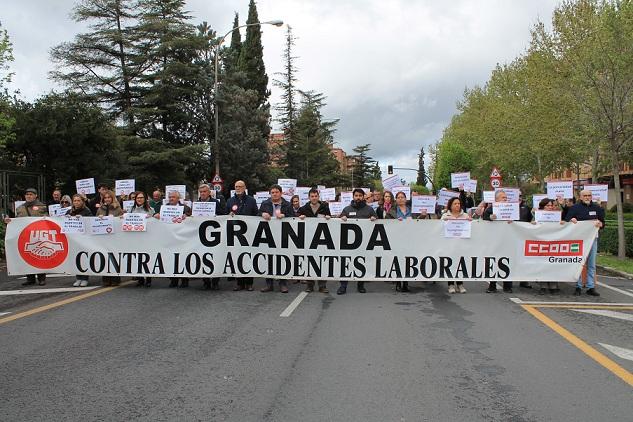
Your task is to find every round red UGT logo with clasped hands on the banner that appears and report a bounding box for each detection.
[18,220,68,270]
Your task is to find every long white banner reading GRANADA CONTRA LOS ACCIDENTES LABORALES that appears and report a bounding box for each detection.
[6,216,597,282]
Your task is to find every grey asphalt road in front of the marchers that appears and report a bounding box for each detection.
[0,268,633,421]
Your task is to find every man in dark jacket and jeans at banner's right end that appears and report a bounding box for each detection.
[565,189,604,296]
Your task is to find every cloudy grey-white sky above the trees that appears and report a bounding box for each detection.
[0,0,558,180]
